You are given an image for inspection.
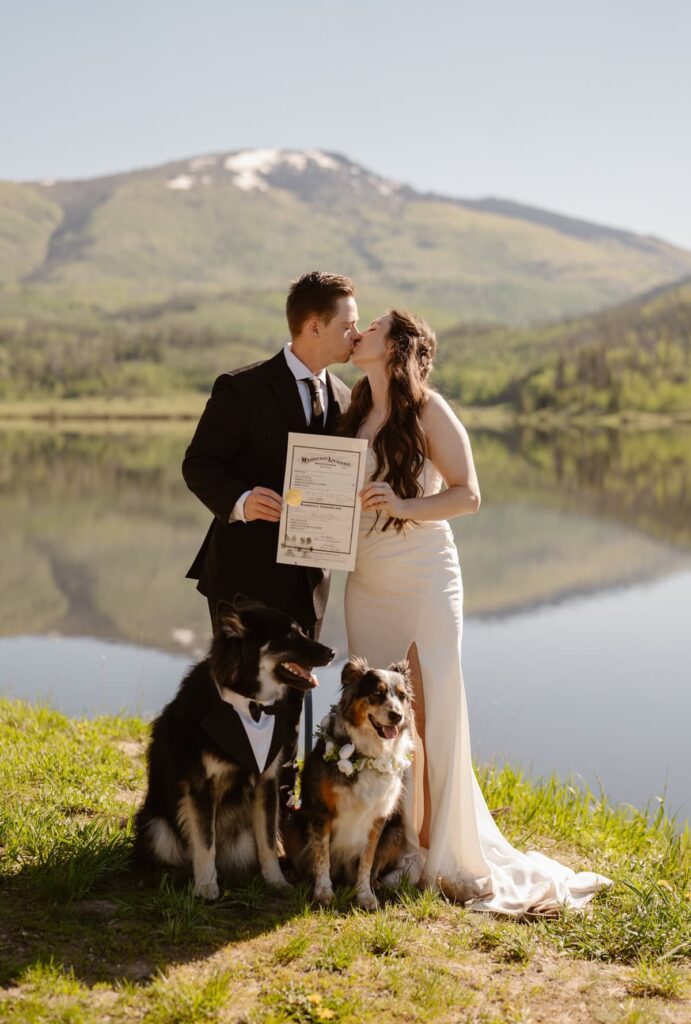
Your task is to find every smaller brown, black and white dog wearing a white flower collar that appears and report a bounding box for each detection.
[284,657,413,910]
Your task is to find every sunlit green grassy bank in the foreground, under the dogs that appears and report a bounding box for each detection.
[0,700,691,1024]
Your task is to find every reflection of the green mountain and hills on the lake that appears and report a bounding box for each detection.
[5,426,691,651]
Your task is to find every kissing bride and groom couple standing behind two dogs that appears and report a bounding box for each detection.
[182,271,609,916]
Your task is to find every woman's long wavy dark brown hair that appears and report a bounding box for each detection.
[340,309,437,532]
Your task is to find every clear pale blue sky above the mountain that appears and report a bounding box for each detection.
[0,0,691,249]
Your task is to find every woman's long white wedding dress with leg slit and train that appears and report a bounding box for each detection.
[345,449,611,916]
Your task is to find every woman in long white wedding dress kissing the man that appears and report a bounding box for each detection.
[342,309,611,916]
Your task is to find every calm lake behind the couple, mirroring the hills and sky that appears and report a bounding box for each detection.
[0,423,691,819]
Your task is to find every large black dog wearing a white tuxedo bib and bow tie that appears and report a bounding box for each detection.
[136,597,334,899]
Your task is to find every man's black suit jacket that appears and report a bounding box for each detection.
[182,351,350,628]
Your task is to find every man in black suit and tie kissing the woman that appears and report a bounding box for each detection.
[182,270,360,792]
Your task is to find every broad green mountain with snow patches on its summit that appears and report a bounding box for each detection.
[0,148,691,396]
